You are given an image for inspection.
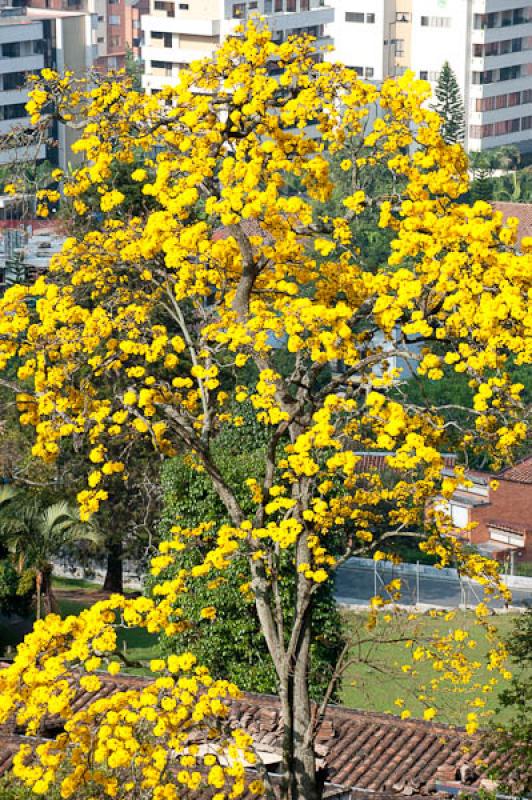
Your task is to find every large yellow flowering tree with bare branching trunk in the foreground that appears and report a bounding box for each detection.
[0,25,530,800]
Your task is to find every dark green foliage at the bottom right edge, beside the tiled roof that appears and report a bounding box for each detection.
[487,608,532,797]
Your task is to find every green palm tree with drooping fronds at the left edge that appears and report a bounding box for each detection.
[0,486,101,619]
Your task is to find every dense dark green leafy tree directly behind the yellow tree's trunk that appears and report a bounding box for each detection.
[152,405,342,700]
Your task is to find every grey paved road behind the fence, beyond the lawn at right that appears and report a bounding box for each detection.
[336,563,532,608]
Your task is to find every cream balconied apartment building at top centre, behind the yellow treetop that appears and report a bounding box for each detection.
[141,0,333,94]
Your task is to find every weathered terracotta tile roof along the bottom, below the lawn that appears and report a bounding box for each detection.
[0,675,508,800]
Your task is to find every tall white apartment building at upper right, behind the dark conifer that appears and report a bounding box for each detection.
[328,0,532,150]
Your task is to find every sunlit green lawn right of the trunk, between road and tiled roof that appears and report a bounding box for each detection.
[341,612,520,724]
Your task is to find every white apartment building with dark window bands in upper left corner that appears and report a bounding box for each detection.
[0,6,93,167]
